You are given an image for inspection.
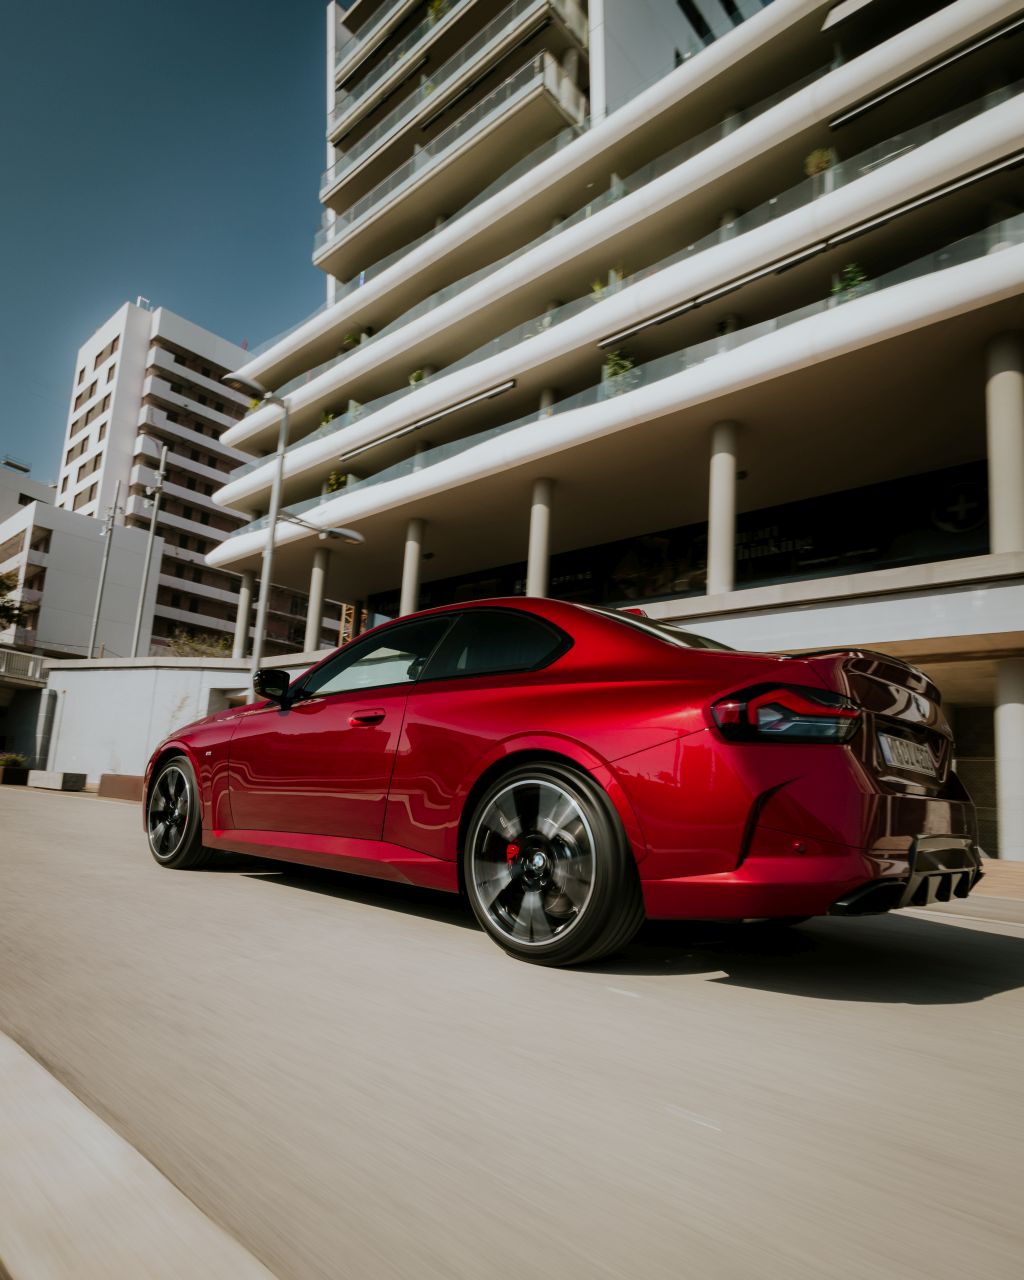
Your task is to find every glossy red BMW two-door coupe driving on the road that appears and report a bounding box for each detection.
[145,598,980,965]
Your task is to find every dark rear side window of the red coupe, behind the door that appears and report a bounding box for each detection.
[424,609,570,680]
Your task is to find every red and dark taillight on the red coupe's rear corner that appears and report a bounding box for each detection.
[710,685,860,742]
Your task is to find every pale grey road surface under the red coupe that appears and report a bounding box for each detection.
[0,787,1024,1280]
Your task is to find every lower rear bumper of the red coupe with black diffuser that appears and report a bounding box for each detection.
[641,836,982,920]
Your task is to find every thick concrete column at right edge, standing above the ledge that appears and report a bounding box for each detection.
[986,333,1024,553]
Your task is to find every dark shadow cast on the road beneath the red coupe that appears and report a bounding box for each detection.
[203,854,1024,1005]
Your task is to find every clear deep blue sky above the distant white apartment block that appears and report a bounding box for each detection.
[0,0,326,481]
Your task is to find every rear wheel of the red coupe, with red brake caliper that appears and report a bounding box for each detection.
[463,760,644,965]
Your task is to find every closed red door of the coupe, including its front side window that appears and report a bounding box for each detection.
[230,616,451,840]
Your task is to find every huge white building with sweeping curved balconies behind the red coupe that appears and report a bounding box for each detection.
[209,0,1024,858]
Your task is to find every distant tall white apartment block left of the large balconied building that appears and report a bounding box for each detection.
[56,298,338,655]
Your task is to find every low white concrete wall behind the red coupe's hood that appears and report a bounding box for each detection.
[37,654,319,785]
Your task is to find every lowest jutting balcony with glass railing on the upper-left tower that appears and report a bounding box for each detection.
[314,54,586,275]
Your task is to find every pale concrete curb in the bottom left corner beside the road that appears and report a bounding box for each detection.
[0,1034,274,1280]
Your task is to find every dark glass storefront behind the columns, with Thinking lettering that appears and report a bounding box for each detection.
[369,462,988,617]
